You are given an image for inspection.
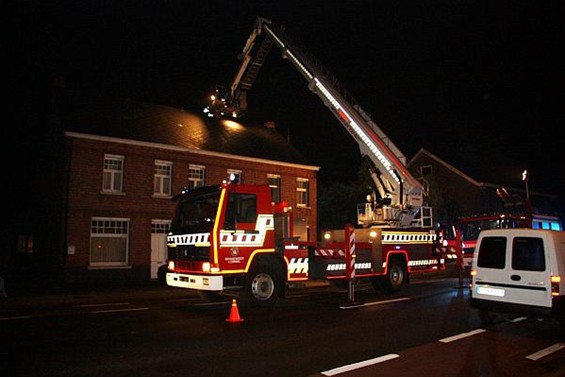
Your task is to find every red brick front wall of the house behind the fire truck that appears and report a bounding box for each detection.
[66,138,317,281]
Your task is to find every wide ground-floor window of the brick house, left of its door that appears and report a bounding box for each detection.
[90,218,129,267]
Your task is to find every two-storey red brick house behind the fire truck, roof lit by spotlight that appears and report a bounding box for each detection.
[17,90,319,285]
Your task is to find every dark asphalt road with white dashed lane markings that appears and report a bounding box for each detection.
[0,266,565,377]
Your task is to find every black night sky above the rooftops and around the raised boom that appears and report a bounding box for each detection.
[15,0,565,214]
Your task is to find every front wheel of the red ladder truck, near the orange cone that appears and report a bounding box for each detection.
[243,263,283,306]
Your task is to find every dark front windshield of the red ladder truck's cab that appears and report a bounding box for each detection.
[171,190,220,234]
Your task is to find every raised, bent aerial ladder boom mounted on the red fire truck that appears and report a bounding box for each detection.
[204,17,434,228]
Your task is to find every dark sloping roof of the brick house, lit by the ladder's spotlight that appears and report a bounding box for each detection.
[59,91,309,164]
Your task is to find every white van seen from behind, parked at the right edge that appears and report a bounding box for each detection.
[470,229,565,323]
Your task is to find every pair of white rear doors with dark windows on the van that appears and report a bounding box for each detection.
[473,232,551,307]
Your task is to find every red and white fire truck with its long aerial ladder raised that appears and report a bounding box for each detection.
[166,18,444,305]
